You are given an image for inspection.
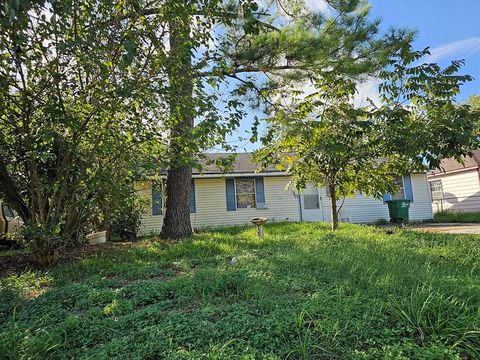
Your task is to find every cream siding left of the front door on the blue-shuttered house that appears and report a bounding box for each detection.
[140,176,300,234]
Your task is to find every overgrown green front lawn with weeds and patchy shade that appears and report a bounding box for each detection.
[0,223,480,359]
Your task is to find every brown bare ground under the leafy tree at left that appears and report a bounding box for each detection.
[0,241,135,277]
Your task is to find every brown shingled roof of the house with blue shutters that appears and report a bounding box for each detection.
[192,153,283,175]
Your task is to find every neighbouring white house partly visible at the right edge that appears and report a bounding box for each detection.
[428,150,480,212]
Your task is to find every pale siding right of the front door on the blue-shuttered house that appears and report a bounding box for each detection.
[320,174,433,223]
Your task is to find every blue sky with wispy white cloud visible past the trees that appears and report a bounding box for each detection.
[227,0,480,152]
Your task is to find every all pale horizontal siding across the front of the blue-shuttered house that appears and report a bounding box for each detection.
[136,174,432,234]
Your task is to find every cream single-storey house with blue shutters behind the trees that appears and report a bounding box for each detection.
[137,153,433,234]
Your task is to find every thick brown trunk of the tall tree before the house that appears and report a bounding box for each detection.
[160,9,194,239]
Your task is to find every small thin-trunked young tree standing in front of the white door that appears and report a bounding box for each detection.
[256,78,406,230]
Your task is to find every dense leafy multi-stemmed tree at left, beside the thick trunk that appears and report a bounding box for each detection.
[0,1,166,262]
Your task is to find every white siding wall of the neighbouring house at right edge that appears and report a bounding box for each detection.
[428,169,480,212]
